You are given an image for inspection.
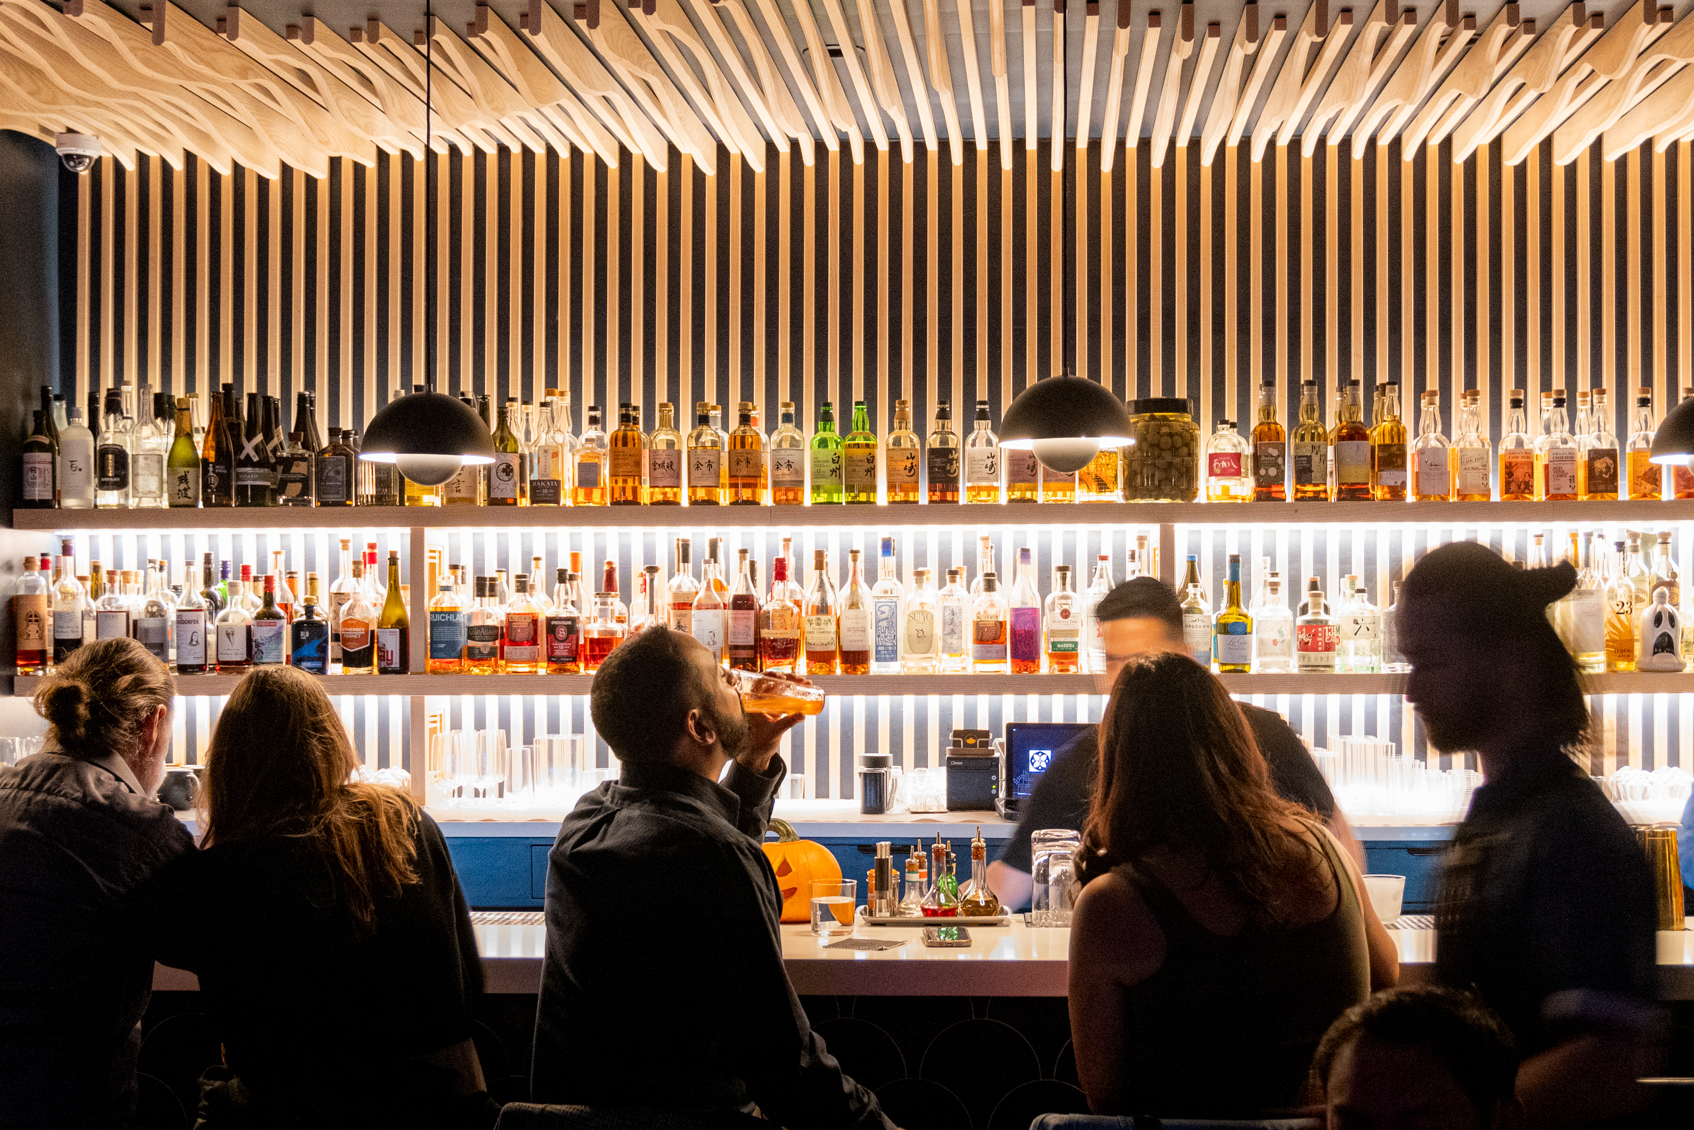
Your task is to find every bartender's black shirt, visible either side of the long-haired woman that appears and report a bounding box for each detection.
[1001,703,1335,872]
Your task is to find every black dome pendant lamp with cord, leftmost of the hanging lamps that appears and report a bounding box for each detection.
[359,3,495,486]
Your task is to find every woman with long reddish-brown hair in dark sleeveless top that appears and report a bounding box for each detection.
[1071,654,1399,1118]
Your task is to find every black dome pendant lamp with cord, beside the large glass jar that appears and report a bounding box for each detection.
[999,12,1130,474]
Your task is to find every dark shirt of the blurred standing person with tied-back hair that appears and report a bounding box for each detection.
[1435,749,1658,1055]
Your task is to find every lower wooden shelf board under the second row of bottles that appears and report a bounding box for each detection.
[12,673,1694,696]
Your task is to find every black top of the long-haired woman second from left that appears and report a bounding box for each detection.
[137,813,483,1125]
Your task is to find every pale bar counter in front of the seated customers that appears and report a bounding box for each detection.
[152,911,1694,1001]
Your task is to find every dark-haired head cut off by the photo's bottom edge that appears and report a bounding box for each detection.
[1311,986,1523,1130]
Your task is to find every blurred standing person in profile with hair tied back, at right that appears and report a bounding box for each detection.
[1399,542,1658,1127]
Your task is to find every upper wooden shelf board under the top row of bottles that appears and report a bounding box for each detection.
[12,500,1694,532]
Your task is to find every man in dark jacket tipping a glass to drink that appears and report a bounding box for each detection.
[530,627,893,1130]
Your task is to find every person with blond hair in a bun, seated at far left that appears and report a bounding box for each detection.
[0,639,195,1128]
